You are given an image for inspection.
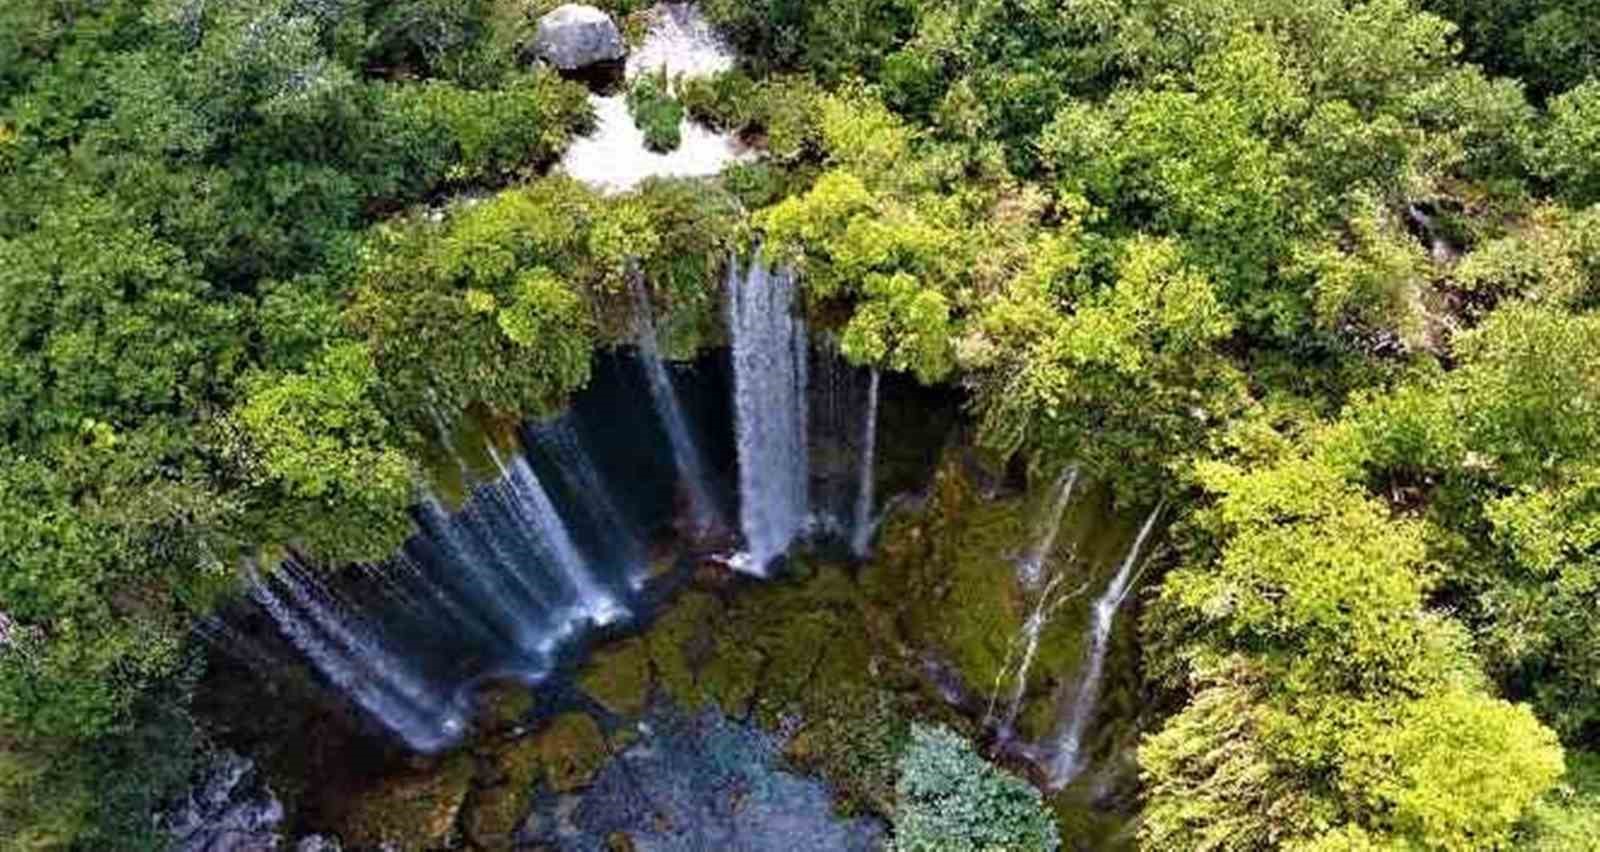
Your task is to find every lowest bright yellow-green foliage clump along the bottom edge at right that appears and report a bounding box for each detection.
[1139,660,1563,852]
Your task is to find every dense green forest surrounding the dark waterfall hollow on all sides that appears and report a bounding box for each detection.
[0,0,1600,850]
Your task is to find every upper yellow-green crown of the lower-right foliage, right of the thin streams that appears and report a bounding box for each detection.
[1162,458,1437,690]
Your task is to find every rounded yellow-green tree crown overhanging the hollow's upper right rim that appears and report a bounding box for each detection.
[962,239,1242,493]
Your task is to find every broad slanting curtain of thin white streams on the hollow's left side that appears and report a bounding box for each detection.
[251,419,640,753]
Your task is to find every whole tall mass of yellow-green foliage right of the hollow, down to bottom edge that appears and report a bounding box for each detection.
[1139,438,1562,850]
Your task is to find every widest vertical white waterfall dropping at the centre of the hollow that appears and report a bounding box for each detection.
[728,258,810,575]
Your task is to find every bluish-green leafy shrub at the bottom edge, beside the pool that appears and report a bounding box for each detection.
[894,724,1061,852]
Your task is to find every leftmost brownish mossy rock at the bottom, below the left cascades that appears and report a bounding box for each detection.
[338,753,474,849]
